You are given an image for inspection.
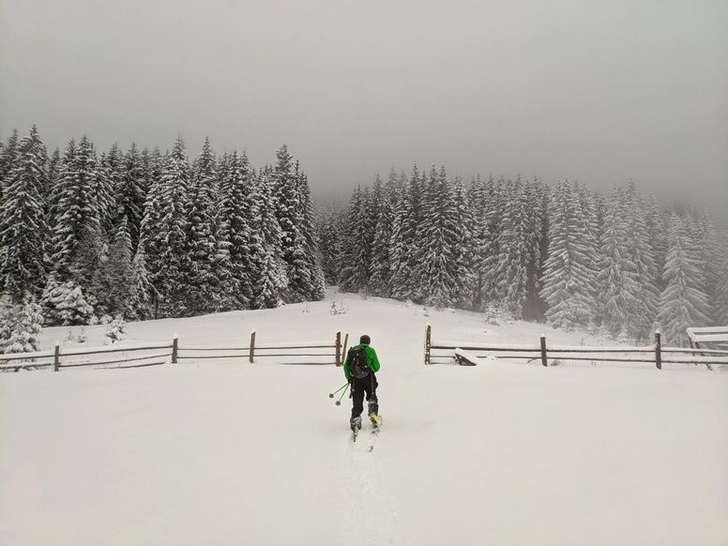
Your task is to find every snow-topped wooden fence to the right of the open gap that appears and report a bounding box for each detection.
[425,324,728,370]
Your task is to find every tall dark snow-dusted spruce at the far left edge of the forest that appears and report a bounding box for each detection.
[0,126,48,301]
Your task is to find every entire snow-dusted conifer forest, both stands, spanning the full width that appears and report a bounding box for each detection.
[0,127,728,352]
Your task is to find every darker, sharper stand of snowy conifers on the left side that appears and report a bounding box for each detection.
[0,126,324,336]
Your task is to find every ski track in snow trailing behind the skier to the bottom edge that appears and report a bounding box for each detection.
[341,428,404,546]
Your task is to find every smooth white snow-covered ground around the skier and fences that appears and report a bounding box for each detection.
[0,294,728,546]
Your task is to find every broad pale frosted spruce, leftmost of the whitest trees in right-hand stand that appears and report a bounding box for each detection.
[541,181,595,329]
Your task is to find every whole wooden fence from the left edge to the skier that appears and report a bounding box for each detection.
[0,330,349,372]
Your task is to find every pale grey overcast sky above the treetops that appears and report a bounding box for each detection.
[0,0,728,209]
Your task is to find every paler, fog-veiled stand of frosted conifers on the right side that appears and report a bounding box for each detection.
[319,165,728,344]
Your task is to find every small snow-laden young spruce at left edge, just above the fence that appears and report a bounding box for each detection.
[0,297,43,354]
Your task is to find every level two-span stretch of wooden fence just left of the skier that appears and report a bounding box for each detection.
[178,330,343,366]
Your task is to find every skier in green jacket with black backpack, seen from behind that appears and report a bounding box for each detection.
[344,334,382,436]
